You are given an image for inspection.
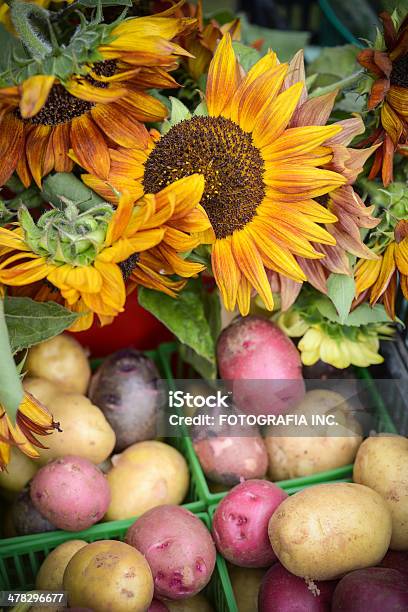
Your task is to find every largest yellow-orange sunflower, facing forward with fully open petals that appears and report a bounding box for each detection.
[83,34,346,314]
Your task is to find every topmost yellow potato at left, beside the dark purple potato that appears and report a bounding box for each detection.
[25,334,91,393]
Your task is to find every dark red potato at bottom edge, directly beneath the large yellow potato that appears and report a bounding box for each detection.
[258,563,336,612]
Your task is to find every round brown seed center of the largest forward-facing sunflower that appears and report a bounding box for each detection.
[143,117,265,238]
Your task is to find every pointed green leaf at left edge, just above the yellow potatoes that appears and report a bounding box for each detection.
[4,297,79,353]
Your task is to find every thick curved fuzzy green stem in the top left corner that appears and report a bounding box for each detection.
[11,0,52,59]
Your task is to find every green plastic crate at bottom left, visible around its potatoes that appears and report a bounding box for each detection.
[0,504,237,612]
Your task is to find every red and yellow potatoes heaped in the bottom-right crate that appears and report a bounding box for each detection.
[213,434,408,612]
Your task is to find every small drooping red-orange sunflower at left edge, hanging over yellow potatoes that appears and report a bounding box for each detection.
[0,392,59,472]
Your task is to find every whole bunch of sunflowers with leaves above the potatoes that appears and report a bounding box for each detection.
[0,0,408,468]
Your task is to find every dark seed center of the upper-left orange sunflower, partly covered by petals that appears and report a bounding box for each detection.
[16,60,116,125]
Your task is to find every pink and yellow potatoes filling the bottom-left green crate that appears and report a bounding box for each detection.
[31,505,216,612]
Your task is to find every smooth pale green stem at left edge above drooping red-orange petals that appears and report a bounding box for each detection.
[0,299,24,424]
